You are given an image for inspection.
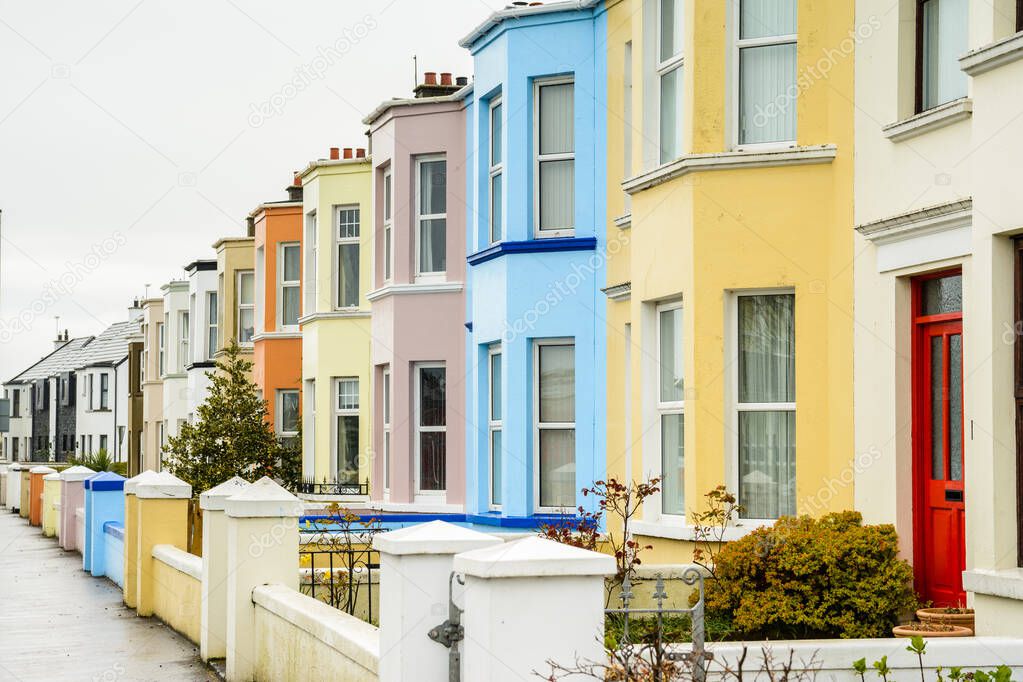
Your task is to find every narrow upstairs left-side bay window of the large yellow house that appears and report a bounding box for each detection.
[657,0,683,164]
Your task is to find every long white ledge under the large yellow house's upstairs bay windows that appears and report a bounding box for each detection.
[622,144,838,194]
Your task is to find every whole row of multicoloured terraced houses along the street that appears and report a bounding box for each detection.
[4,0,1023,634]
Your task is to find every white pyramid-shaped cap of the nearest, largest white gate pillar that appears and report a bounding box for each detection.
[453,537,617,578]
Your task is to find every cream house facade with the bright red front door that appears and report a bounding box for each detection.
[852,0,1023,635]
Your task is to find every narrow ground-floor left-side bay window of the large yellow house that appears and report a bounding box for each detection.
[657,303,685,515]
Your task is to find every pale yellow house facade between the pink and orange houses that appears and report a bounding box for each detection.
[299,149,373,495]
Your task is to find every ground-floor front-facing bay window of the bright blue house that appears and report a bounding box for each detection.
[533,340,576,510]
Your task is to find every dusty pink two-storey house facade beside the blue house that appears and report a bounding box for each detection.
[364,74,469,512]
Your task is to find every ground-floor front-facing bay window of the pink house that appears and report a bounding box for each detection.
[414,363,447,494]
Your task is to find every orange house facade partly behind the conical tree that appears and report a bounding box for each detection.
[249,179,302,438]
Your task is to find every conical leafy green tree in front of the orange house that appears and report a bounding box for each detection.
[164,339,301,495]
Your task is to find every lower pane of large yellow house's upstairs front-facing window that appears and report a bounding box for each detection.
[739,43,797,144]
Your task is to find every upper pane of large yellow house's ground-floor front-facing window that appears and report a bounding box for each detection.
[739,293,796,403]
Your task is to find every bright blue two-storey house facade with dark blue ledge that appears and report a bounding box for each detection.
[461,0,607,525]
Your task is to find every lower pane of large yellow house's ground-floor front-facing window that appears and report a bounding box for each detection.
[739,412,796,518]
